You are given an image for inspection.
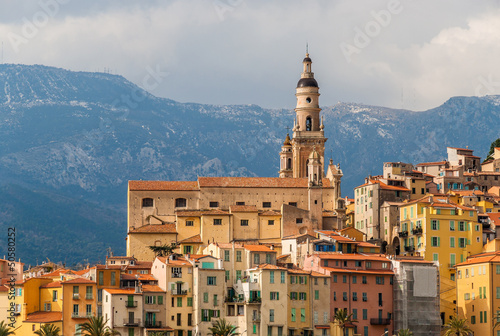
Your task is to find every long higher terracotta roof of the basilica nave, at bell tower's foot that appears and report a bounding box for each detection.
[198,177,330,188]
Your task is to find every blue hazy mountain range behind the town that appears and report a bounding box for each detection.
[0,64,500,265]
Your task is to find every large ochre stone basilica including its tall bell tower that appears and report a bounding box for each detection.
[127,54,345,260]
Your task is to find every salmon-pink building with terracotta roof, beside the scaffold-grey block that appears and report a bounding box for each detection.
[304,252,394,336]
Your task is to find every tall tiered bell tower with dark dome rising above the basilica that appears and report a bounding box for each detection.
[290,53,327,180]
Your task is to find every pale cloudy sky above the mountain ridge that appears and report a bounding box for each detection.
[0,0,500,111]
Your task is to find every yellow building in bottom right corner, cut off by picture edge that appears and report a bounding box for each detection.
[456,251,500,336]
